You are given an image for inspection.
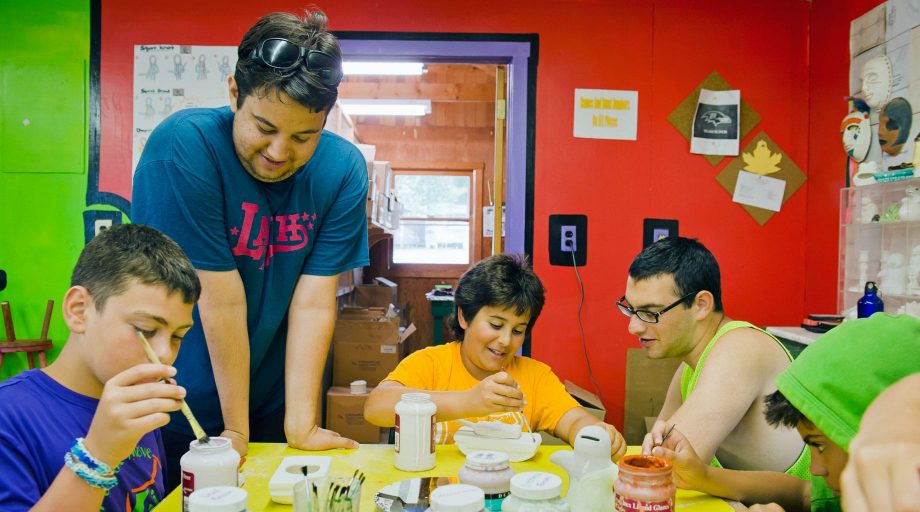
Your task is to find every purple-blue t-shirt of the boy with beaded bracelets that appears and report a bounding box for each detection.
[0,369,166,512]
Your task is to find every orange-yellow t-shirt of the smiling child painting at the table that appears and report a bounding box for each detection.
[386,341,579,444]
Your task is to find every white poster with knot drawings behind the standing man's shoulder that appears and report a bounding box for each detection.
[131,44,237,169]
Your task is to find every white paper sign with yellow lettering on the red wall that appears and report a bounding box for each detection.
[572,89,639,140]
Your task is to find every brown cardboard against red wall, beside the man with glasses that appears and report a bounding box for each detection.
[623,348,680,445]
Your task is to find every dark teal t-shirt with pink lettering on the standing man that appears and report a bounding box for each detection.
[131,107,369,435]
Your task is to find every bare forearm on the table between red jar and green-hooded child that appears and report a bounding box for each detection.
[695,466,811,512]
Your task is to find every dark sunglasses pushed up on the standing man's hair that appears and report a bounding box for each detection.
[250,37,344,87]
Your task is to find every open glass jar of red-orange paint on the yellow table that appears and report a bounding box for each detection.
[613,455,677,512]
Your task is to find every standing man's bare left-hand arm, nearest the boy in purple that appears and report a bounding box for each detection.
[197,270,249,439]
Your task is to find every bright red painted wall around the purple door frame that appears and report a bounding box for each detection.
[102,0,871,426]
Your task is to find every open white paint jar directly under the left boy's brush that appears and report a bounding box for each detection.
[179,437,240,512]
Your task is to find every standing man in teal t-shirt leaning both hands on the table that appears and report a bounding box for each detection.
[132,7,368,486]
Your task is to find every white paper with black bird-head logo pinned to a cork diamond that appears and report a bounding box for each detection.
[690,89,741,156]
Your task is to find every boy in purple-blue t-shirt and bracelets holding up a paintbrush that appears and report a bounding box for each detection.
[0,224,201,512]
